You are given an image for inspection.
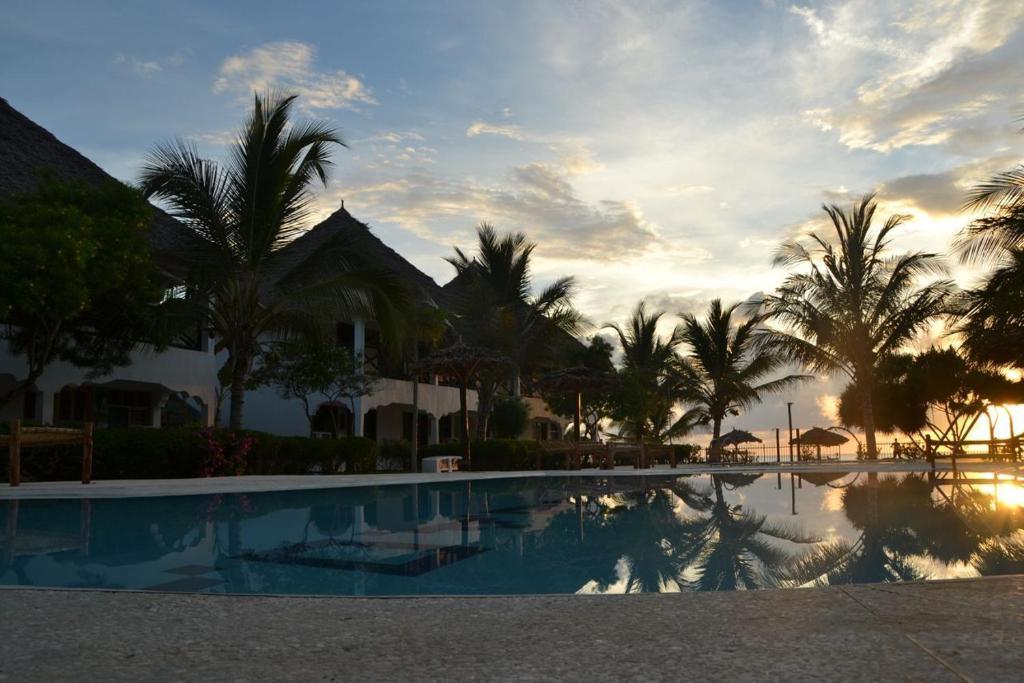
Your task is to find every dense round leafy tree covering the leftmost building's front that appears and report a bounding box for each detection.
[0,179,163,408]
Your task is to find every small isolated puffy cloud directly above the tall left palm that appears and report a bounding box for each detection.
[213,41,377,111]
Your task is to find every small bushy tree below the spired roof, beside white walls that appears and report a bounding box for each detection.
[249,338,376,436]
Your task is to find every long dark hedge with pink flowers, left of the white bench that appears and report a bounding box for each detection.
[0,427,377,481]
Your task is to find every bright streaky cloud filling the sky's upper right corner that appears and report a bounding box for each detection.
[791,0,1024,153]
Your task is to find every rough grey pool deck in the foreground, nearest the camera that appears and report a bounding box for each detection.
[0,577,1024,681]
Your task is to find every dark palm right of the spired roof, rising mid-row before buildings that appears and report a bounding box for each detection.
[447,223,584,437]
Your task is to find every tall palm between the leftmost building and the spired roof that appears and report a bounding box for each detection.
[141,94,403,429]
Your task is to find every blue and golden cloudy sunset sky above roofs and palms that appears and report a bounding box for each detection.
[0,0,1024,430]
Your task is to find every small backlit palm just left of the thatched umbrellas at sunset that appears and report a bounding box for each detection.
[680,299,811,462]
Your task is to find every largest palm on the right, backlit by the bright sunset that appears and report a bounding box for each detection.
[763,195,953,459]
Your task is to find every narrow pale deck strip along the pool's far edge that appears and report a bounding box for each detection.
[0,460,1022,501]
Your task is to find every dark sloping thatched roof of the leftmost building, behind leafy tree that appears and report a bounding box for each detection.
[0,97,195,272]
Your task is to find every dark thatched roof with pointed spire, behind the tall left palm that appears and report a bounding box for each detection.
[269,207,446,305]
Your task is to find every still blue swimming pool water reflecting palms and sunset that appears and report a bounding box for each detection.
[0,473,1024,595]
